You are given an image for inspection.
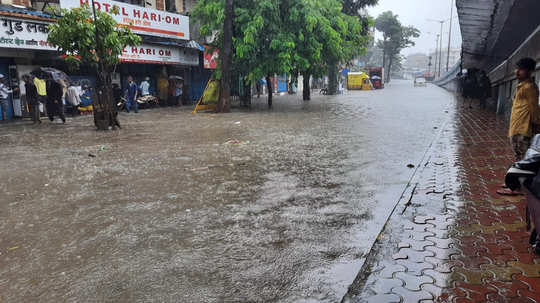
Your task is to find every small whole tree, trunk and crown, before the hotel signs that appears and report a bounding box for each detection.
[48,5,141,130]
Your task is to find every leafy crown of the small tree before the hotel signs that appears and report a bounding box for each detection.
[48,5,141,71]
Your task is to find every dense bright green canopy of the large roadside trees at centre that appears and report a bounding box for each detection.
[192,0,376,82]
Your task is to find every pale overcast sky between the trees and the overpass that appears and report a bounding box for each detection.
[368,0,461,55]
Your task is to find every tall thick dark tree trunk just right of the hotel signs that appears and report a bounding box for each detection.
[217,0,234,113]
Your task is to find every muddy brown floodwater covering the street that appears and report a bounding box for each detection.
[0,81,453,302]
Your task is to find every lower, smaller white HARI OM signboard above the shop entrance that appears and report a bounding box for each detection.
[120,44,199,65]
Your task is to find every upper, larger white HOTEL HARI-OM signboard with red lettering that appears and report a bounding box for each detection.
[60,0,189,40]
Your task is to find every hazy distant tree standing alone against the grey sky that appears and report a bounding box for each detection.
[375,11,420,82]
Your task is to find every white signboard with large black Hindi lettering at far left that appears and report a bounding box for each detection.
[0,17,56,50]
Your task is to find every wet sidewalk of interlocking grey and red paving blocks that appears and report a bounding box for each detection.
[343,103,540,303]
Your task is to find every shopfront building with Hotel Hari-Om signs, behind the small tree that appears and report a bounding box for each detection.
[0,0,212,119]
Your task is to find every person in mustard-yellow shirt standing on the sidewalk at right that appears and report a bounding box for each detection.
[497,58,540,196]
